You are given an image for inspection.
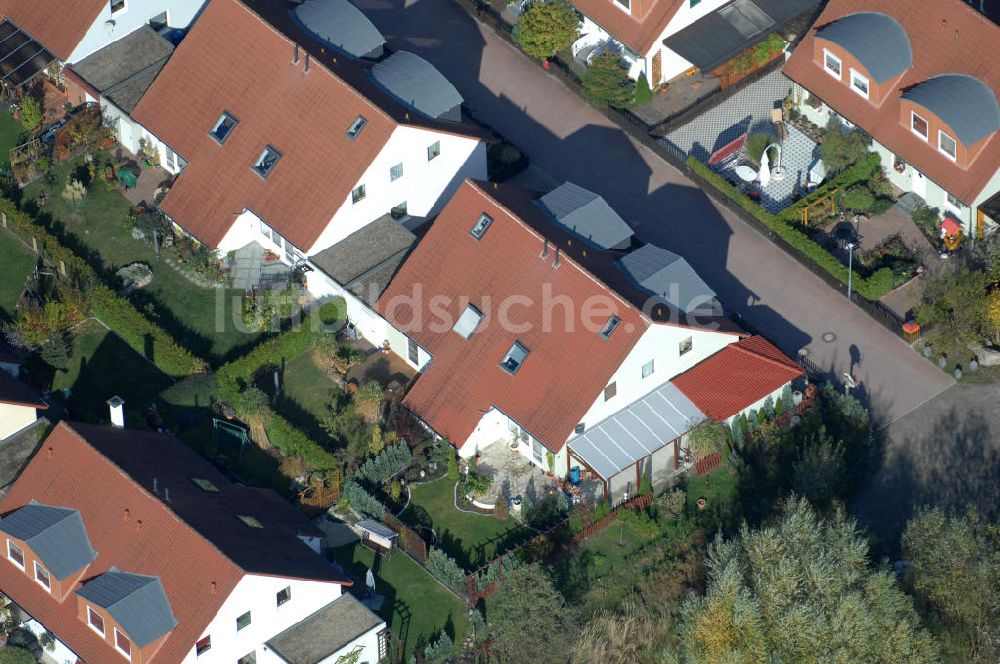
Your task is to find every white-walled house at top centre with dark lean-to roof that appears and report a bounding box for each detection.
[572,0,817,88]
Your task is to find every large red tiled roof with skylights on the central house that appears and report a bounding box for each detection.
[378,181,650,451]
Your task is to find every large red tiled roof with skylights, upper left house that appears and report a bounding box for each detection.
[133,0,396,251]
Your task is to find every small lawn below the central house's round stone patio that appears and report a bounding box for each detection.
[400,477,534,571]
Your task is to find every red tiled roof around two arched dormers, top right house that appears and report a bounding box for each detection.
[784,0,1000,205]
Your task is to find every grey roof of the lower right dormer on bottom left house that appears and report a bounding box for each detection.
[77,567,177,648]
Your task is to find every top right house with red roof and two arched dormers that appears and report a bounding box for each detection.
[785,0,1000,237]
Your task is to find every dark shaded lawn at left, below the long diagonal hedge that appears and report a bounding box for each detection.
[52,321,172,426]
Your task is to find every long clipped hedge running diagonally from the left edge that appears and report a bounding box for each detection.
[0,197,207,378]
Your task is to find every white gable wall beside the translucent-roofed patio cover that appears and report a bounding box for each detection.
[566,324,739,438]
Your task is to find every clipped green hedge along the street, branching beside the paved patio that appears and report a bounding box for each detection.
[687,155,893,301]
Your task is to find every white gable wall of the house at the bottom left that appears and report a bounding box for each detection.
[184,572,341,664]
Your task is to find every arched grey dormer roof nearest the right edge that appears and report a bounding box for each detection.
[903,74,1000,145]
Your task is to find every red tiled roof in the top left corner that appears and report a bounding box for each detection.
[0,0,104,60]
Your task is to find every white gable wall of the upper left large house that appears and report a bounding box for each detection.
[306,126,486,256]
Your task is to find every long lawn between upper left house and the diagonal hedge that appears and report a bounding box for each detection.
[24,154,261,363]
